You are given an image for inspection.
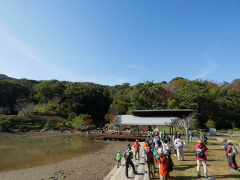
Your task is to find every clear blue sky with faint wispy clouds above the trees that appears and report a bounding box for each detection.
[0,0,240,85]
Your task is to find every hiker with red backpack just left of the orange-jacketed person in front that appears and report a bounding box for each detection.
[144,143,155,179]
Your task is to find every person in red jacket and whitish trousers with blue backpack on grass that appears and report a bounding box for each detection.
[194,140,208,178]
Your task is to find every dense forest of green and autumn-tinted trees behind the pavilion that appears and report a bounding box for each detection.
[0,74,240,128]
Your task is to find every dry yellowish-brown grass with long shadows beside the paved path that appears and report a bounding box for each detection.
[150,141,240,180]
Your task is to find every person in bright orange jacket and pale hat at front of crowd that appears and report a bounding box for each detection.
[154,148,169,180]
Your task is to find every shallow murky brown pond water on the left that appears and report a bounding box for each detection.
[0,136,105,172]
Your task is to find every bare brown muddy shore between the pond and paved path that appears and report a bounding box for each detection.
[0,133,133,180]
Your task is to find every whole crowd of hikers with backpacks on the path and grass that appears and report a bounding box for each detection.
[117,131,238,180]
